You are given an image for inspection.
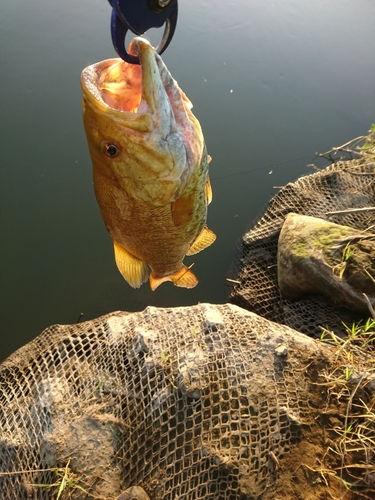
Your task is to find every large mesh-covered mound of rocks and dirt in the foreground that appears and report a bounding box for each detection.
[0,304,374,500]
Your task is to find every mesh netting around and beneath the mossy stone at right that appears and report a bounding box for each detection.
[229,160,375,336]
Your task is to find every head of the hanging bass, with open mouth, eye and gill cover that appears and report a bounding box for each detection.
[81,37,205,206]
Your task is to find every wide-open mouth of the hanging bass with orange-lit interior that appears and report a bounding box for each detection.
[81,37,203,148]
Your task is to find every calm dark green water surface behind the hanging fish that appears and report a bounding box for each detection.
[0,0,375,360]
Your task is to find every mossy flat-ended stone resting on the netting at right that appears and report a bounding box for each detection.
[277,213,375,312]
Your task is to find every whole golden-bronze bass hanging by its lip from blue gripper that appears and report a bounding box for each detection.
[81,37,216,290]
